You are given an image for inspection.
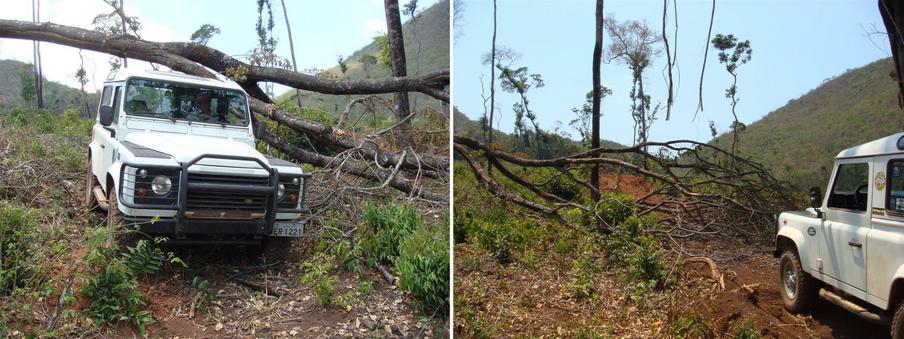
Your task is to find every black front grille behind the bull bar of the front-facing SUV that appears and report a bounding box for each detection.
[185,173,271,219]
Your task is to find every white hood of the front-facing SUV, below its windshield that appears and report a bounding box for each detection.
[125,133,267,163]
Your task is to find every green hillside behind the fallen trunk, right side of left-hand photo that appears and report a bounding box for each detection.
[279,0,450,113]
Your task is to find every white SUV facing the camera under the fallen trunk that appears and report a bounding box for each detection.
[85,69,310,242]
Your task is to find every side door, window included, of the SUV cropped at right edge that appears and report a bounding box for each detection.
[819,158,871,298]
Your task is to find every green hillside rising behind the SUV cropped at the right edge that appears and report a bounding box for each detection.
[713,58,904,189]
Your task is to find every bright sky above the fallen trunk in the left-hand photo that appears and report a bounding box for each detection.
[0,0,437,93]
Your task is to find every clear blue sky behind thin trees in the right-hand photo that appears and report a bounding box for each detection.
[453,0,891,144]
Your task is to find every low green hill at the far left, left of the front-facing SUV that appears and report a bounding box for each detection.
[0,60,98,115]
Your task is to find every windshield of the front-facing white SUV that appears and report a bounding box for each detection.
[123,79,248,126]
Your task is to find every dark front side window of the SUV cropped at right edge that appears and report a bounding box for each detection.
[828,163,869,211]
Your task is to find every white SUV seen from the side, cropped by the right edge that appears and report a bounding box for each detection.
[775,133,904,338]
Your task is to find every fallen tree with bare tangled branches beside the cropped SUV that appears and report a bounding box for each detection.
[453,136,792,238]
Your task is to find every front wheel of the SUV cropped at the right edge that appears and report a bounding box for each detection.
[778,249,819,313]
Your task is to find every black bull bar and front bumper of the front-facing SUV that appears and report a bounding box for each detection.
[117,154,311,236]
